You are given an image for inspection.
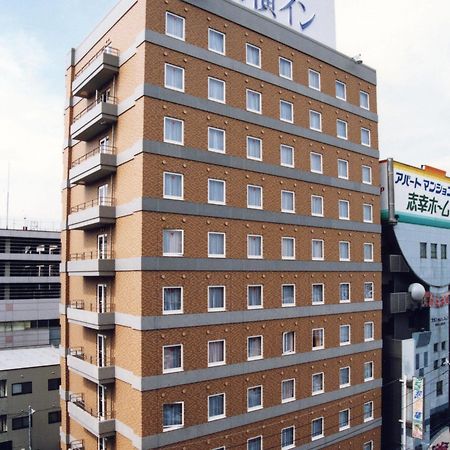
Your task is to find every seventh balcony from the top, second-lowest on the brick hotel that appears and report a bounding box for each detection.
[67,347,115,384]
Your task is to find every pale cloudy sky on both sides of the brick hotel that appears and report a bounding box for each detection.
[0,0,450,220]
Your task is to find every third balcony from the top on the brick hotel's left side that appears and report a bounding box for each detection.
[69,145,117,184]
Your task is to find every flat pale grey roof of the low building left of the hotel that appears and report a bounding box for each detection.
[0,346,59,371]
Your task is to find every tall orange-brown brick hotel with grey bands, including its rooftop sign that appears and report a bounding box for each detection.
[61,0,382,450]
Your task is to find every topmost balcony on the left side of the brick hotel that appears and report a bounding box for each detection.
[72,46,119,98]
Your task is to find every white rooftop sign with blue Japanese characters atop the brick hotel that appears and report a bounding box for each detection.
[232,0,336,48]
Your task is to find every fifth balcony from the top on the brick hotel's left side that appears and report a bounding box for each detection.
[67,250,116,277]
